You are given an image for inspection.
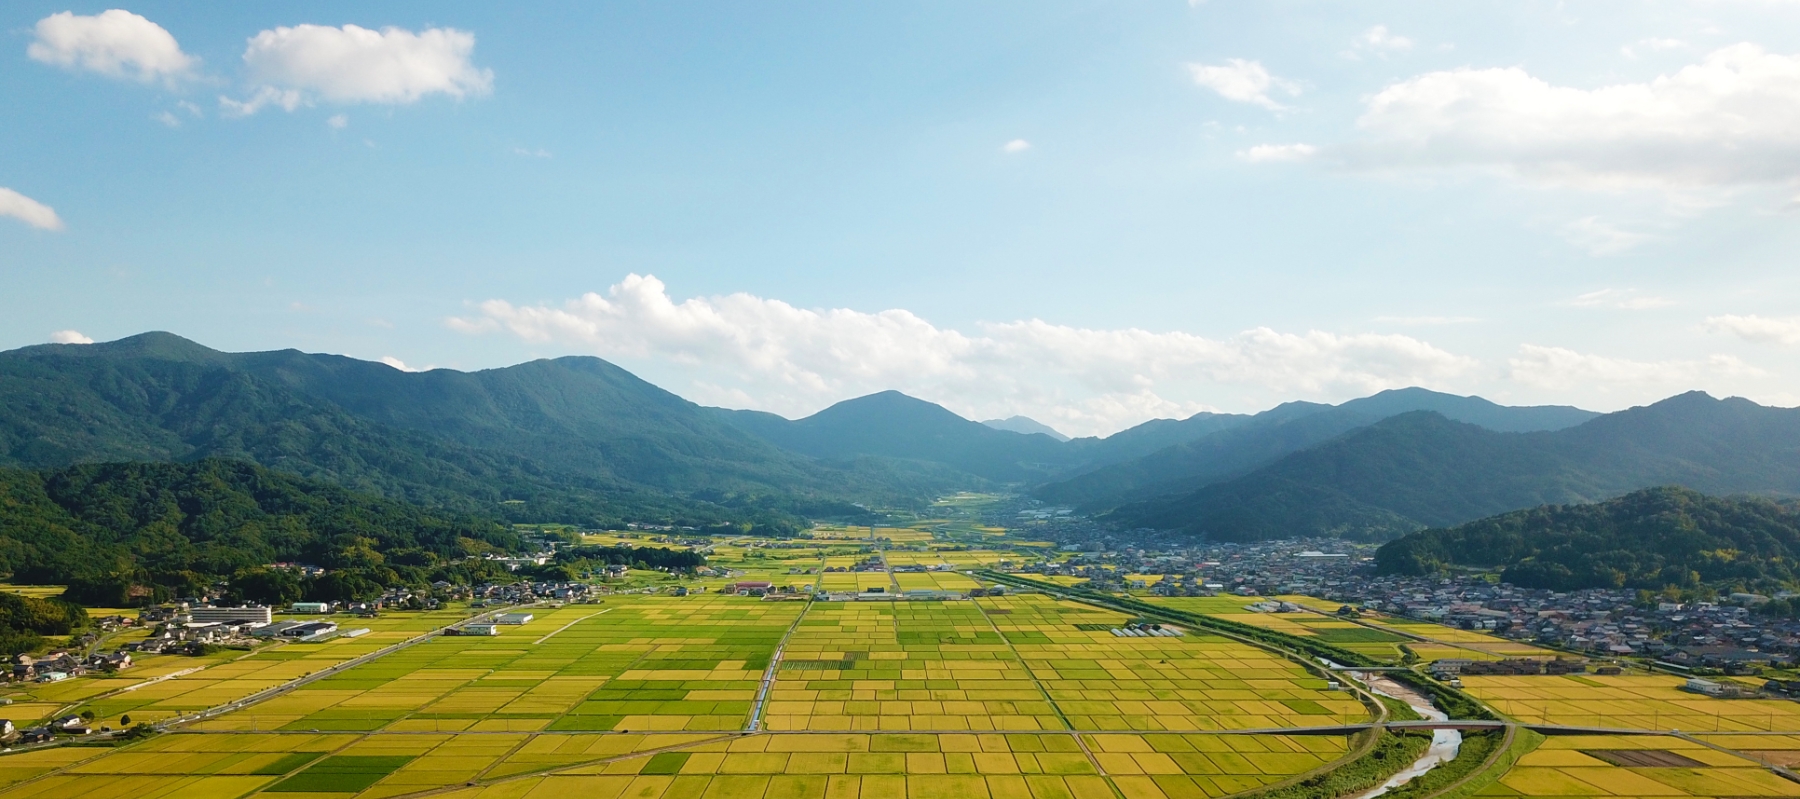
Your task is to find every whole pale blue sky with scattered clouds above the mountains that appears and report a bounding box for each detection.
[10,0,1800,434]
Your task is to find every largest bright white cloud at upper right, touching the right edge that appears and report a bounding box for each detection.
[1339,43,1800,189]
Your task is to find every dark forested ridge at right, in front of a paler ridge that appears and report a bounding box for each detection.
[1107,392,1800,540]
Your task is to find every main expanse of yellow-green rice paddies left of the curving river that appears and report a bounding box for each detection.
[0,586,1368,799]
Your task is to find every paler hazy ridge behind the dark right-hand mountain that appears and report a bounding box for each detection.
[1033,389,1600,511]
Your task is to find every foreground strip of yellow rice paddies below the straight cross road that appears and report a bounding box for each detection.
[0,732,1345,799]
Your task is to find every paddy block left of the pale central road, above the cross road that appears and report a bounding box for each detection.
[180,594,803,732]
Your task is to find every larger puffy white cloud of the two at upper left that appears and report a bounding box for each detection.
[220,25,493,115]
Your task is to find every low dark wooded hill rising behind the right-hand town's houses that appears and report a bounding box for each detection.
[1375,486,1800,590]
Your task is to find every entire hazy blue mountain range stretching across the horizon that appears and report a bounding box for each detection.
[0,333,1800,540]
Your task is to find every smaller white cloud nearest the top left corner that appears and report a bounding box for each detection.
[25,9,198,83]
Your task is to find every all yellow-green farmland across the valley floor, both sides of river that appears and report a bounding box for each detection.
[10,522,1800,799]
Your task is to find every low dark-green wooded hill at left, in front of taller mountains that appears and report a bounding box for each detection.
[0,461,520,606]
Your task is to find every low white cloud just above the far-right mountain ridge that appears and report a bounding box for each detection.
[1508,344,1766,392]
